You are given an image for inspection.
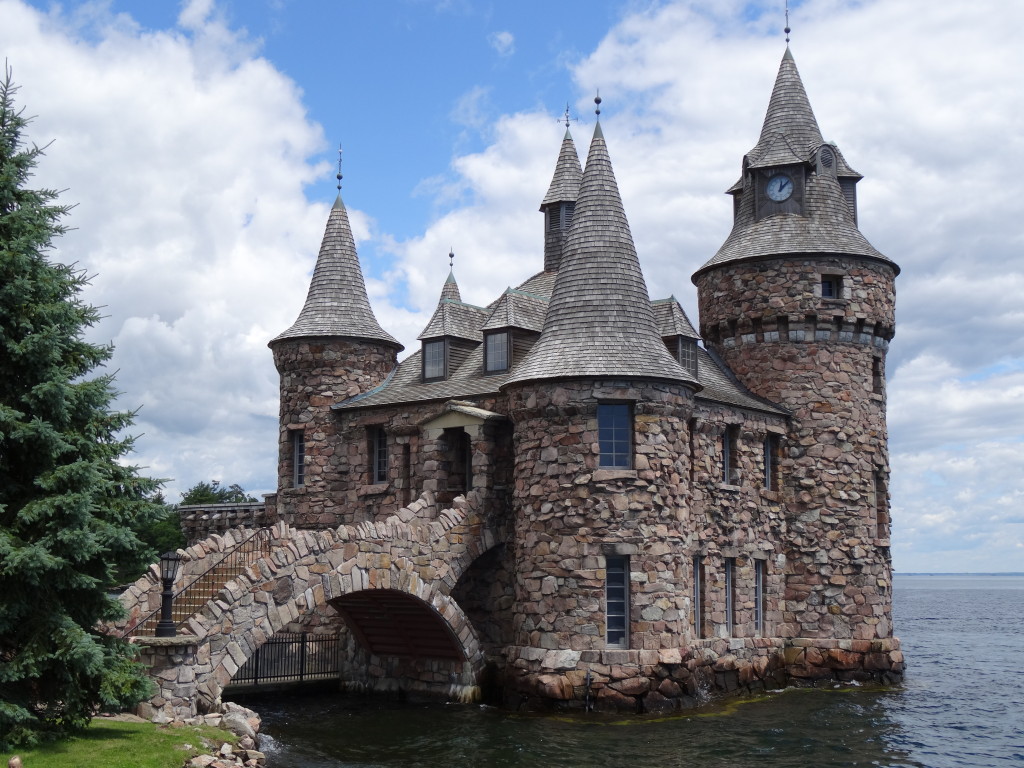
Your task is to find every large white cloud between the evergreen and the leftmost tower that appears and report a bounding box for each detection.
[0,0,325,499]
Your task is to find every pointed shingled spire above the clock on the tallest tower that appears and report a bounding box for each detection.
[746,45,824,168]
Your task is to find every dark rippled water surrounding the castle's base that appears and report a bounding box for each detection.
[235,575,1024,768]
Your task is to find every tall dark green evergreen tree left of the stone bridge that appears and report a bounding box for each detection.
[0,67,159,750]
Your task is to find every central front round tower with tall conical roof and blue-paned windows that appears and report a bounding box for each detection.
[503,115,699,671]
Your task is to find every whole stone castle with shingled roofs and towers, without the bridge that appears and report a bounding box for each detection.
[178,48,903,709]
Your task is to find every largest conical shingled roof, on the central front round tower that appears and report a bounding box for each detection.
[507,124,695,384]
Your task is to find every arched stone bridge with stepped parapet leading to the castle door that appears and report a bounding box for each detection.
[118,494,506,720]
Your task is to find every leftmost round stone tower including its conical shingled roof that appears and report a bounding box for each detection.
[268,189,402,526]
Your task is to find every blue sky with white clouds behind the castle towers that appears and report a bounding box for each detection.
[0,0,1024,572]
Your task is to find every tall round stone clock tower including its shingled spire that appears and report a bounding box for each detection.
[693,48,899,640]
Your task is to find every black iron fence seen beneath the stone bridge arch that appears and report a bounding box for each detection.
[231,632,341,685]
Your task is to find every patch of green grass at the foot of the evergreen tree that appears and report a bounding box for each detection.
[0,718,238,768]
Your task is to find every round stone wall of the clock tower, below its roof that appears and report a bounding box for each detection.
[697,258,894,641]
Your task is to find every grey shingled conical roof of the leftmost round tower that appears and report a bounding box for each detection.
[270,193,403,350]
